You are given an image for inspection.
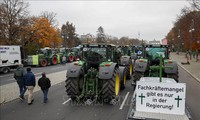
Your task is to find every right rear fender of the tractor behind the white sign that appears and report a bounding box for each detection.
[164,61,178,73]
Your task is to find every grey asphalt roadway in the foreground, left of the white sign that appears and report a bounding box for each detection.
[0,80,133,120]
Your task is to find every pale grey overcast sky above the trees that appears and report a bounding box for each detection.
[28,0,189,41]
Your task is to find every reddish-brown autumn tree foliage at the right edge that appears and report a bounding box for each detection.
[166,8,200,51]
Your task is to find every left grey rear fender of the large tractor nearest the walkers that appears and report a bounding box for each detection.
[66,62,84,77]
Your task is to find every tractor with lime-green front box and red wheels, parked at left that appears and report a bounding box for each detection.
[28,48,60,67]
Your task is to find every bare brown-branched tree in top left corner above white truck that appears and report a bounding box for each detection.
[0,0,28,45]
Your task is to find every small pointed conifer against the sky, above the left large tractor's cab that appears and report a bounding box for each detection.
[97,26,106,43]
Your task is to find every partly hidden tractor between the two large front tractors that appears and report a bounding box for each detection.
[117,46,134,79]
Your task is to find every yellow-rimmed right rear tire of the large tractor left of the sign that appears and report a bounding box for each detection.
[102,68,120,102]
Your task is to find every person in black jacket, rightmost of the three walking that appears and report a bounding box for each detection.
[38,72,51,103]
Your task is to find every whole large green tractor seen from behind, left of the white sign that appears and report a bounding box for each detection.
[65,44,126,103]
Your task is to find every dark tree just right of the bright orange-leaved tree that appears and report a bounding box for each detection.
[61,22,80,48]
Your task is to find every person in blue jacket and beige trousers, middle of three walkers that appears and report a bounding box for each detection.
[24,68,35,105]
